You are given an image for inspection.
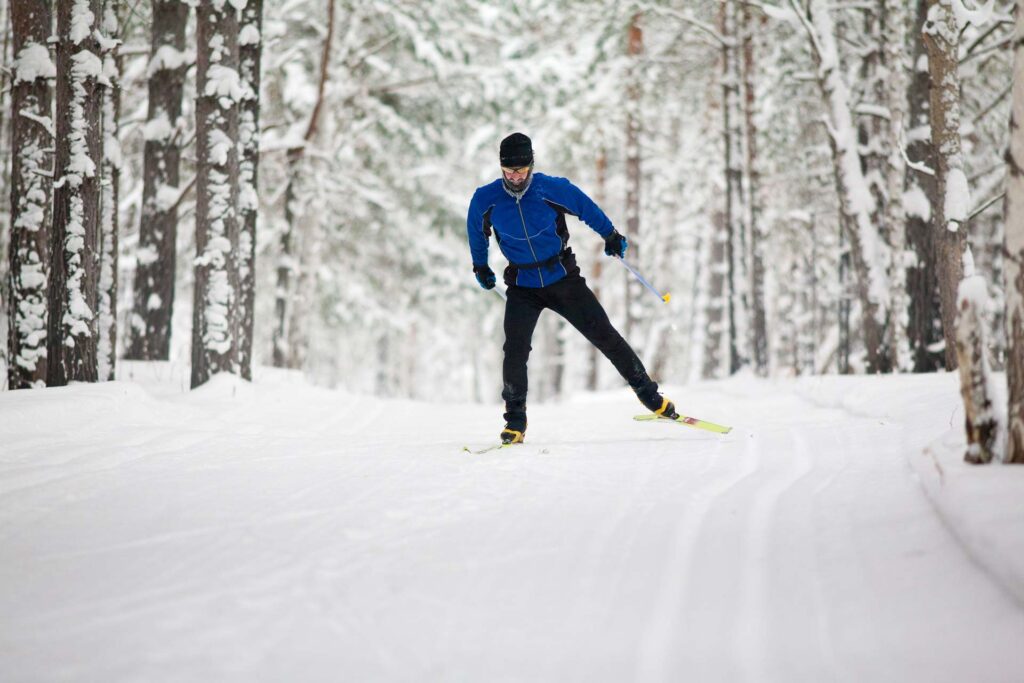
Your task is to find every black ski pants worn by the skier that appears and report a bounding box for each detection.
[502,273,657,421]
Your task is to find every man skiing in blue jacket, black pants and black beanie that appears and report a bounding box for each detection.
[466,133,678,443]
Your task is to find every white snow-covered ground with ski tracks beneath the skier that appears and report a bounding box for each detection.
[0,365,1024,682]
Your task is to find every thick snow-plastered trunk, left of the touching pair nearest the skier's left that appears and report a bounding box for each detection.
[191,2,242,388]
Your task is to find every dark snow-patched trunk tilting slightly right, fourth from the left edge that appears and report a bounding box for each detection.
[125,0,189,360]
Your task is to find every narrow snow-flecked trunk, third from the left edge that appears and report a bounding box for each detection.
[97,0,121,381]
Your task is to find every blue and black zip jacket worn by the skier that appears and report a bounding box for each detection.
[466,173,615,288]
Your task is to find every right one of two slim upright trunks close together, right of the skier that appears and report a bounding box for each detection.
[739,4,768,377]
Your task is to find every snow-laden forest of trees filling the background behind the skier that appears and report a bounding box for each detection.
[0,0,1024,462]
